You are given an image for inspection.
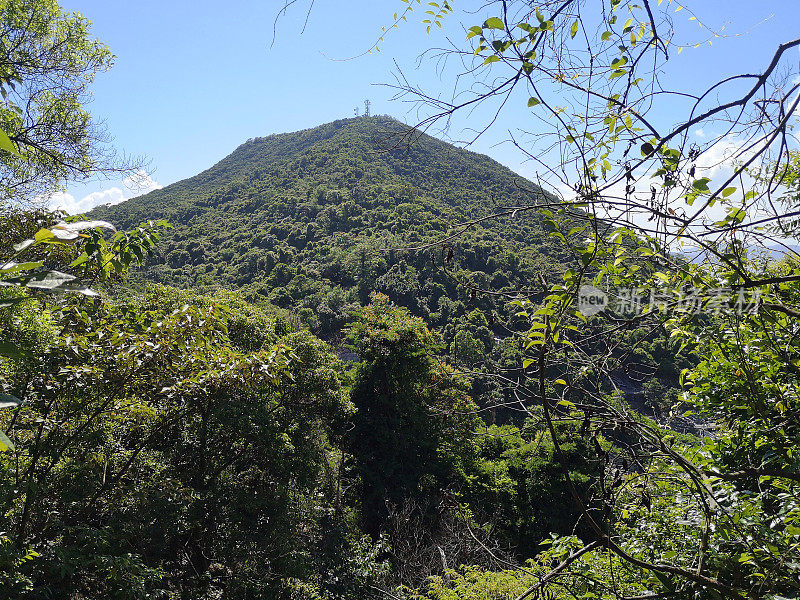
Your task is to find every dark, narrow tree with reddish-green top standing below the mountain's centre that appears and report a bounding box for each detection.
[347,294,477,537]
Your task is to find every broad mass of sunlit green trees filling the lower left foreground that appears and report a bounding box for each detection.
[0,278,388,598]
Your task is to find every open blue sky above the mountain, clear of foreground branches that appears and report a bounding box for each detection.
[51,0,800,216]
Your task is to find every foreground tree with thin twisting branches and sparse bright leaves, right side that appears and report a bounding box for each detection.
[304,0,800,598]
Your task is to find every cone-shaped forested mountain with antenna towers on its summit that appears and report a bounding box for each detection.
[93,116,566,340]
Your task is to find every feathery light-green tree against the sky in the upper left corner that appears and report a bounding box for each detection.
[0,0,136,204]
